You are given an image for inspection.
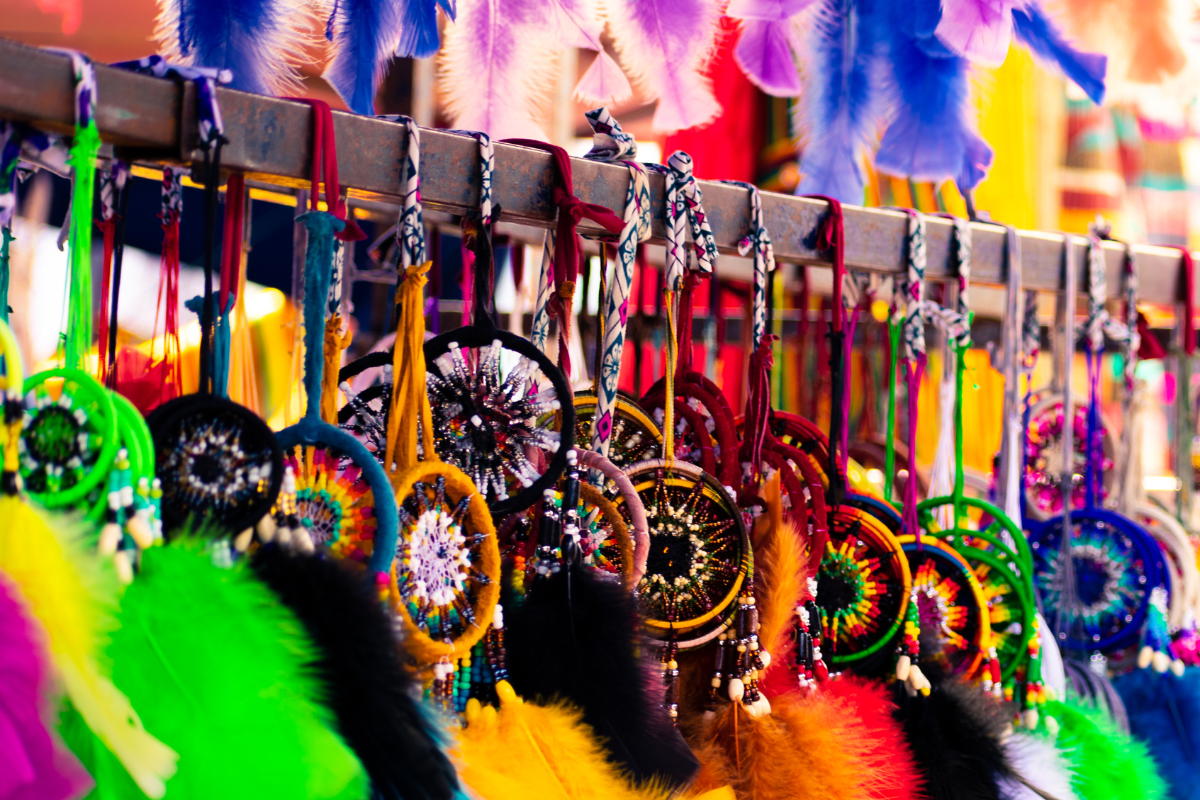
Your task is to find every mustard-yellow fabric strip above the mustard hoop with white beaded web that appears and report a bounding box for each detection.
[384,261,437,477]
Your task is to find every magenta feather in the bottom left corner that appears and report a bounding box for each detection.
[0,573,92,800]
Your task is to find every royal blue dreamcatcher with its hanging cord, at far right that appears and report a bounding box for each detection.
[1030,234,1163,651]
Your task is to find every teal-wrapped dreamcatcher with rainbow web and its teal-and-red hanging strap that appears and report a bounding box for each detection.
[267,101,397,575]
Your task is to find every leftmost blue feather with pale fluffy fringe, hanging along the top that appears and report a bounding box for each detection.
[154,0,310,95]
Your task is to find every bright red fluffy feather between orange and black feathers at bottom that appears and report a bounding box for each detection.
[820,673,921,800]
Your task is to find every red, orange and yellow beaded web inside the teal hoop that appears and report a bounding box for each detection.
[284,445,376,561]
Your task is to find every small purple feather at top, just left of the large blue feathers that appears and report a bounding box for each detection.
[725,0,816,97]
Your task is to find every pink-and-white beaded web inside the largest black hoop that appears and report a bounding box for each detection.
[426,339,562,503]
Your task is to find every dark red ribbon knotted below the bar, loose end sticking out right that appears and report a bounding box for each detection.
[504,139,625,374]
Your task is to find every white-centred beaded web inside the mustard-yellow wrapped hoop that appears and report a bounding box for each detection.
[396,475,491,642]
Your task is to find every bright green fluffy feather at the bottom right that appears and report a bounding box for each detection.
[1045,700,1168,800]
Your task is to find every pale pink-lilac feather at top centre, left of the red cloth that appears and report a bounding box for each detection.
[607,0,721,133]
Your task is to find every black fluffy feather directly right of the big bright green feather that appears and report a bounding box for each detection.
[251,545,458,800]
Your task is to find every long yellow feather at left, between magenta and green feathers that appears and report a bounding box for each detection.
[0,495,176,798]
